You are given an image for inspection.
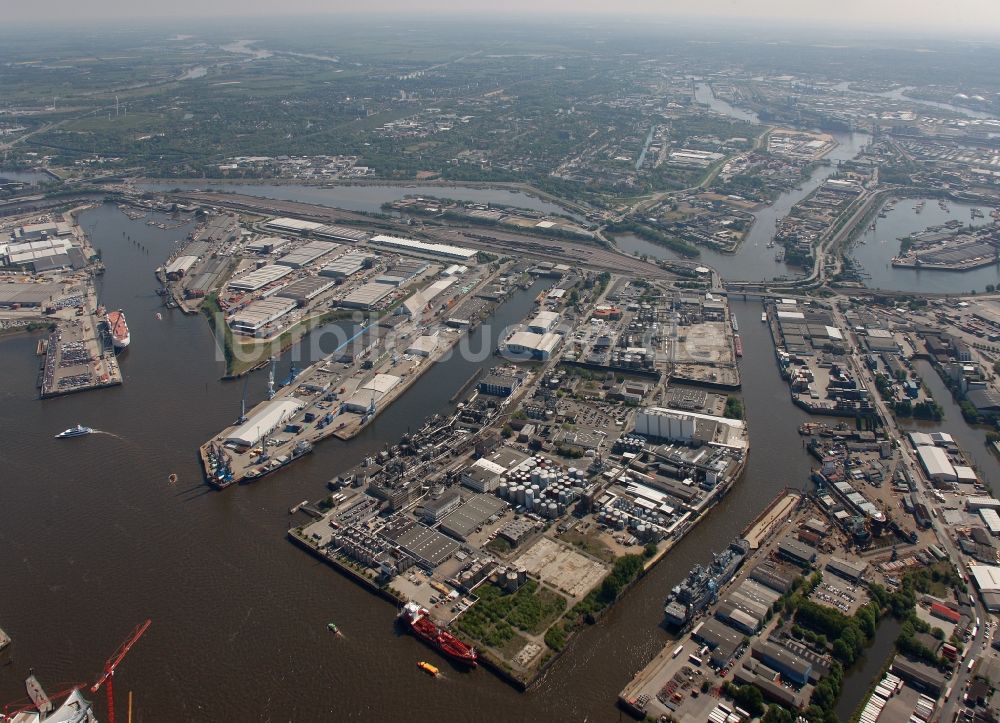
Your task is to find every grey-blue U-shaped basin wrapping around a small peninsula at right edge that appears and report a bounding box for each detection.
[850,198,1000,294]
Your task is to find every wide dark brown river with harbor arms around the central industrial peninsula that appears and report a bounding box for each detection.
[0,206,832,722]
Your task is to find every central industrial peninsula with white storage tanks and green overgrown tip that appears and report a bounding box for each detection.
[288,279,749,688]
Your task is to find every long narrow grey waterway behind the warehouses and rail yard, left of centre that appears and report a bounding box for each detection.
[138,179,579,218]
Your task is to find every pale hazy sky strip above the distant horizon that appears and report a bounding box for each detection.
[11,0,1000,36]
